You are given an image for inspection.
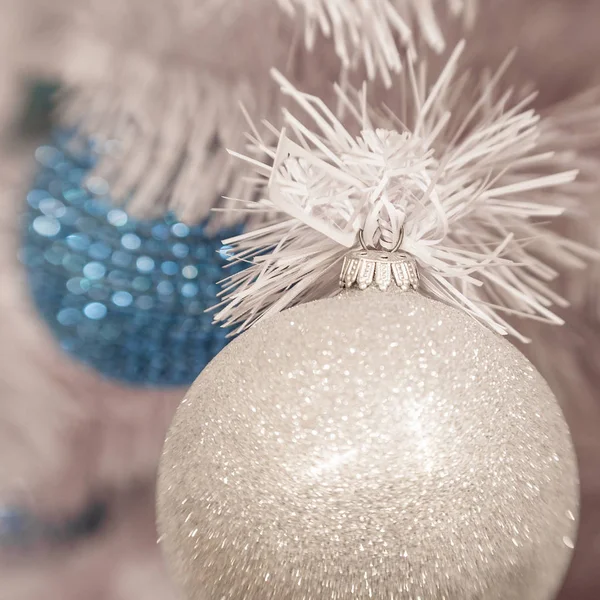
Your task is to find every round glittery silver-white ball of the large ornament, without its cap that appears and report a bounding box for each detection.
[158,290,579,600]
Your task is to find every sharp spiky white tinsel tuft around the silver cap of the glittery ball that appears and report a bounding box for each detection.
[216,43,598,341]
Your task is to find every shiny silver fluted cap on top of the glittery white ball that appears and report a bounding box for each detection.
[340,249,419,292]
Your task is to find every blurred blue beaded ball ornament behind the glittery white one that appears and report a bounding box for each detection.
[20,131,240,386]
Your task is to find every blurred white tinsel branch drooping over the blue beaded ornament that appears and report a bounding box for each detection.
[56,0,302,222]
